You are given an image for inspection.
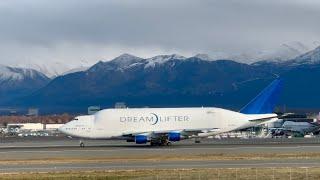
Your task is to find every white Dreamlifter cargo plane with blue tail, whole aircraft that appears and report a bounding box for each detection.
[59,79,282,147]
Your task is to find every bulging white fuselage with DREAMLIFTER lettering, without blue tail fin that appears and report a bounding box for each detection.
[59,108,276,139]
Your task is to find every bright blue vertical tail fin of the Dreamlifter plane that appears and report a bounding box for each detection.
[240,79,282,114]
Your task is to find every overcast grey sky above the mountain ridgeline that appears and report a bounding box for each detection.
[0,0,320,64]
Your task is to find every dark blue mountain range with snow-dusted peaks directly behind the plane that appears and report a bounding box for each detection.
[6,43,320,111]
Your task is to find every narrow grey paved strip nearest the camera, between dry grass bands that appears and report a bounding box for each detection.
[0,160,320,173]
